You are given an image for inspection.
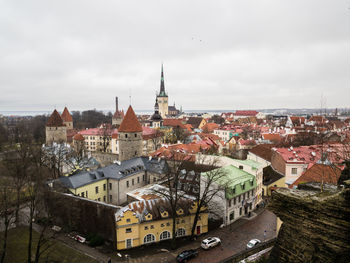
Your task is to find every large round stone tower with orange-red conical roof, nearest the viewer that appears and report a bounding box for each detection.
[118,105,142,161]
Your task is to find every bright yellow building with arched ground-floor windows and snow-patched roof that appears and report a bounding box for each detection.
[116,199,208,250]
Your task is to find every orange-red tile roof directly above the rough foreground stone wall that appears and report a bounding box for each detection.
[290,163,341,187]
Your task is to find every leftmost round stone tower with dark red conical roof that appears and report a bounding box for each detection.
[45,110,67,144]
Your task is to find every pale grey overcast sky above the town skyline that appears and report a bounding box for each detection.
[0,0,350,111]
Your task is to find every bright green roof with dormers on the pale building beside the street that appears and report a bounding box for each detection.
[202,165,256,199]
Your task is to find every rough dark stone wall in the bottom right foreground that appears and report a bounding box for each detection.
[268,186,350,263]
